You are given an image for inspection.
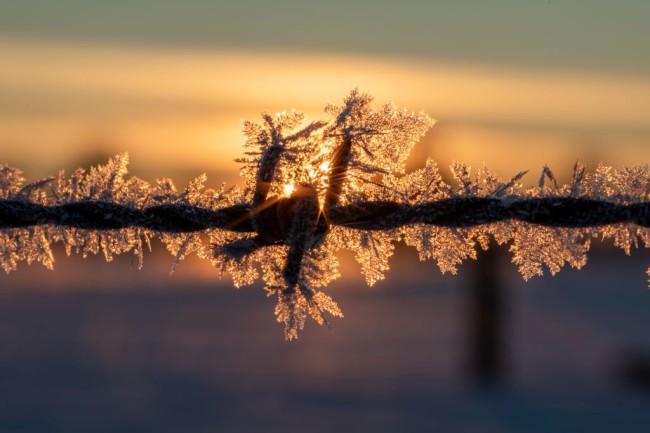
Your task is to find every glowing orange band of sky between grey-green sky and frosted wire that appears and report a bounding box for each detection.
[0,39,650,183]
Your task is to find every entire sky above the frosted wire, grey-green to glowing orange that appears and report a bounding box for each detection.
[0,0,650,182]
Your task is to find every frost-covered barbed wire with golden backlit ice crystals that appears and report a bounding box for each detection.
[0,90,650,339]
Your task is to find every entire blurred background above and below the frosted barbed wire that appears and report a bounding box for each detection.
[0,0,650,432]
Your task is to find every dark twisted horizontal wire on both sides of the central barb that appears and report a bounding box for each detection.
[0,196,650,233]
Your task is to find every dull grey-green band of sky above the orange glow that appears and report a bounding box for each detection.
[5,0,650,74]
